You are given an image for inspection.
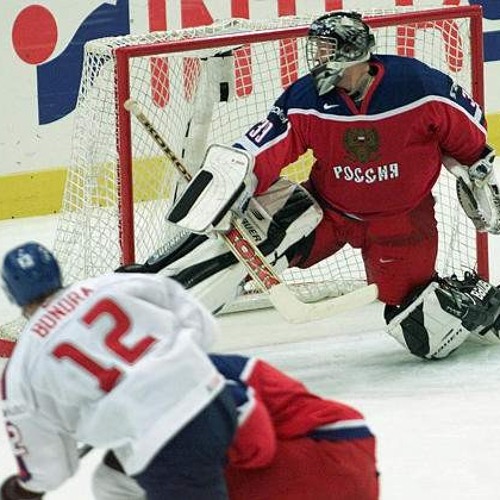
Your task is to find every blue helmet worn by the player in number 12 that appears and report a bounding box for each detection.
[2,242,62,307]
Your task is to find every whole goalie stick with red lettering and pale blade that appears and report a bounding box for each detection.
[124,99,378,323]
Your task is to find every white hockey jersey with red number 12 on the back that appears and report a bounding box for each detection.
[2,274,224,491]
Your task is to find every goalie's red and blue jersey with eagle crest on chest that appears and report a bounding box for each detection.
[236,55,486,220]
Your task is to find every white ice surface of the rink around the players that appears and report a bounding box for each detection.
[0,216,500,500]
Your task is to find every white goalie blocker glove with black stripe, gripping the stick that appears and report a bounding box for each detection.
[166,144,255,233]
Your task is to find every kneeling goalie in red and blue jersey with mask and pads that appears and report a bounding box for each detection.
[120,11,500,359]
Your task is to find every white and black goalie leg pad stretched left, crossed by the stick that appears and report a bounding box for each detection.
[117,178,323,313]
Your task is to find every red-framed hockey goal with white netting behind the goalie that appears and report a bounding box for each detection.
[54,6,488,308]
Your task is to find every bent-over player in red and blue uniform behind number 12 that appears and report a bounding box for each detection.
[93,355,379,500]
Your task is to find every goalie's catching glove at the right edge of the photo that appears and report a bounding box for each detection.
[444,146,500,234]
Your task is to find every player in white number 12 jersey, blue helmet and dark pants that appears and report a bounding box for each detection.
[1,242,236,500]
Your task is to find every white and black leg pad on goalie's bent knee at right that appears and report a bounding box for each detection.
[387,281,470,359]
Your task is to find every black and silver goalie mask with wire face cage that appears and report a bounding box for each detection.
[306,12,375,95]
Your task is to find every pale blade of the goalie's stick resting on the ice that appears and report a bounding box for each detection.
[269,283,378,323]
